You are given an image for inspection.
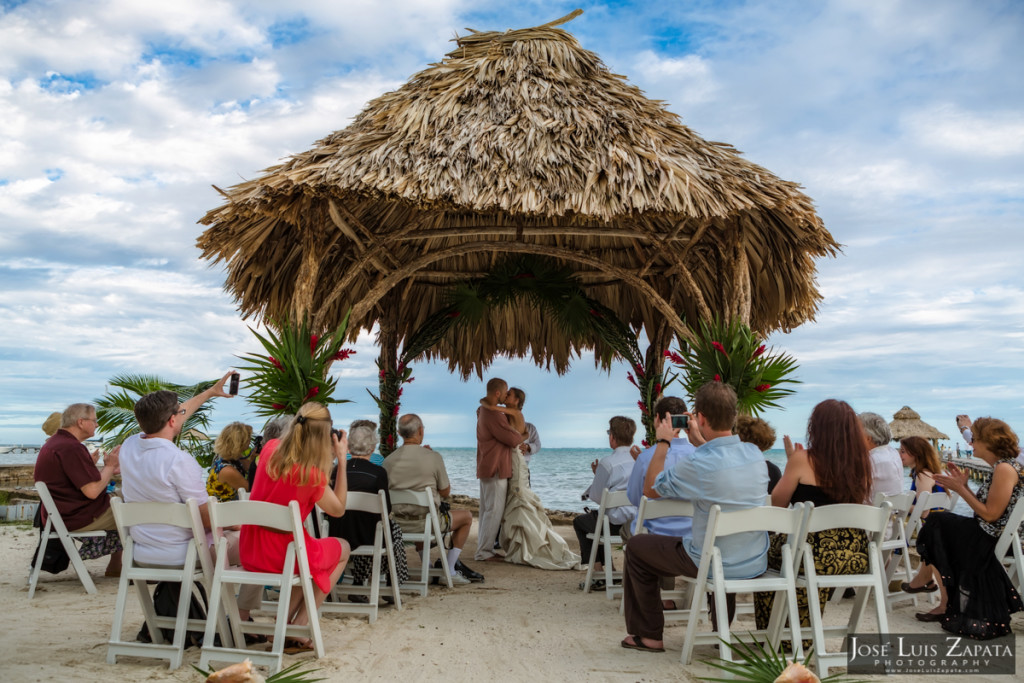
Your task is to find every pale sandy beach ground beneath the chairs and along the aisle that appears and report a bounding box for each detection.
[0,524,1024,683]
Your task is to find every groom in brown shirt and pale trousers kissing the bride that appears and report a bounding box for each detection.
[474,377,522,560]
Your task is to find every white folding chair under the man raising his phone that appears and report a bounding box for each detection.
[106,498,227,670]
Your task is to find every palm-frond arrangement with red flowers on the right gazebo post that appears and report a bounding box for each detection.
[665,318,800,417]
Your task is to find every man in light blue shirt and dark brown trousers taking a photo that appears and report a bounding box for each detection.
[622,382,768,652]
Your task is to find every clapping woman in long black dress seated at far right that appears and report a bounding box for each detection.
[911,418,1024,640]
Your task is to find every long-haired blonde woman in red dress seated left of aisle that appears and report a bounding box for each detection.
[240,403,349,651]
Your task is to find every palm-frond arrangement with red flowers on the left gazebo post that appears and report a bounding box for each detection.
[239,314,355,417]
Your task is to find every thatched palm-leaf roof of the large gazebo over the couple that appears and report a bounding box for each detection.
[199,10,839,371]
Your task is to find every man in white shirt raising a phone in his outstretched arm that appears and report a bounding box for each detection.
[120,373,260,620]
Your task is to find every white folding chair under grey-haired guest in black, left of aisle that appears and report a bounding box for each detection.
[321,489,401,624]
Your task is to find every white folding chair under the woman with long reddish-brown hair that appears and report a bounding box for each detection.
[797,503,892,676]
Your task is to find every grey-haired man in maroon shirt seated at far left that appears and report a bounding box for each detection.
[35,403,121,575]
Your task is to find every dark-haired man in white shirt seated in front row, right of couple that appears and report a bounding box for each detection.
[572,416,637,581]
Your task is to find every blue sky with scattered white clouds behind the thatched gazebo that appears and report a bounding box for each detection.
[0,0,1024,454]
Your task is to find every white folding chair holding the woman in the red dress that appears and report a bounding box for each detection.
[199,498,324,673]
